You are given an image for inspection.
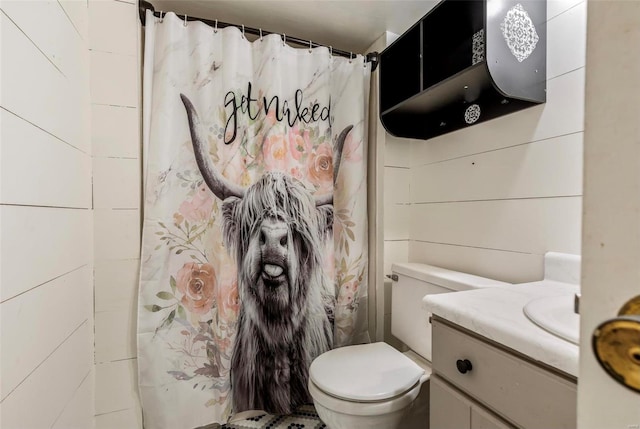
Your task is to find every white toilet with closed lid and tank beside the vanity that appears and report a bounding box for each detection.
[309,263,508,429]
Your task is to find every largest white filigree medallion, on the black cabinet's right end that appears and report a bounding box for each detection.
[500,3,540,62]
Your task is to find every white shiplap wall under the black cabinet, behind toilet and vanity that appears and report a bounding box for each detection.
[385,0,586,282]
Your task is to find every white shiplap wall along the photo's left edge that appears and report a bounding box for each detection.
[0,0,94,429]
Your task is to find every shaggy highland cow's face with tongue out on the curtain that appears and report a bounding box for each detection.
[228,172,324,328]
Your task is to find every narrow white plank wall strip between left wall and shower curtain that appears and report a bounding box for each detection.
[89,0,142,429]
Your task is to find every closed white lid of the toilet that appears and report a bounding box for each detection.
[309,342,424,402]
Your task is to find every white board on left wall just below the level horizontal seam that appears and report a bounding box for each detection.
[0,206,93,301]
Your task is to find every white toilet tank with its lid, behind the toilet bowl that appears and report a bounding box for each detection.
[391,263,509,362]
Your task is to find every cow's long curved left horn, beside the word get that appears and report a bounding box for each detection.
[180,94,250,200]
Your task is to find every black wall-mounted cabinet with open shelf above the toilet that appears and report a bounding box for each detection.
[380,0,547,139]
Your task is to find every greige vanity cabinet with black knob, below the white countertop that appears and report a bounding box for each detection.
[430,316,576,429]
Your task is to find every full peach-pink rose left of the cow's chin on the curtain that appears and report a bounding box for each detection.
[176,262,216,314]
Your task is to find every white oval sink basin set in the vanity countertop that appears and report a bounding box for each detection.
[523,294,580,344]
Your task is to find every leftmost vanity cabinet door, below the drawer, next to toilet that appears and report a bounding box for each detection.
[429,376,471,429]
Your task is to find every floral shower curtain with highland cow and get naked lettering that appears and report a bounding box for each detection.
[138,12,370,429]
